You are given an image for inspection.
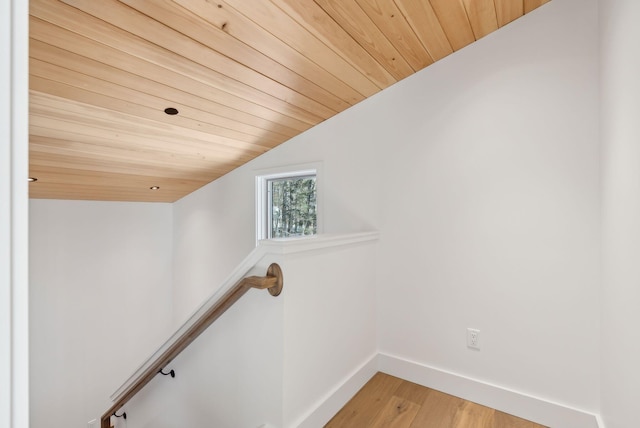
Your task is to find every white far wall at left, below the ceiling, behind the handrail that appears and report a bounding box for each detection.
[29,200,172,428]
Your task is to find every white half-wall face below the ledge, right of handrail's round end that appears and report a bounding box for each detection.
[282,242,378,428]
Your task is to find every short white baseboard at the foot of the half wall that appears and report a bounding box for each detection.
[291,354,378,428]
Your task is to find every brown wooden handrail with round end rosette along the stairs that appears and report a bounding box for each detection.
[100,263,283,428]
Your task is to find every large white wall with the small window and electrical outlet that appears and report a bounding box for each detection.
[174,0,601,418]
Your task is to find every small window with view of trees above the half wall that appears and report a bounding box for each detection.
[257,169,318,240]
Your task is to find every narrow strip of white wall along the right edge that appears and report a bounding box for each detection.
[600,0,640,428]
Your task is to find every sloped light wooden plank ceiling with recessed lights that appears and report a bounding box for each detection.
[29,0,548,202]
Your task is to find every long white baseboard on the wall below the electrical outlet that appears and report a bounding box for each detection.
[377,354,604,428]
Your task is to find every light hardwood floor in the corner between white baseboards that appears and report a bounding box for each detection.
[325,373,544,428]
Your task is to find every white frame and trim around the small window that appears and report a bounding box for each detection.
[256,163,324,245]
